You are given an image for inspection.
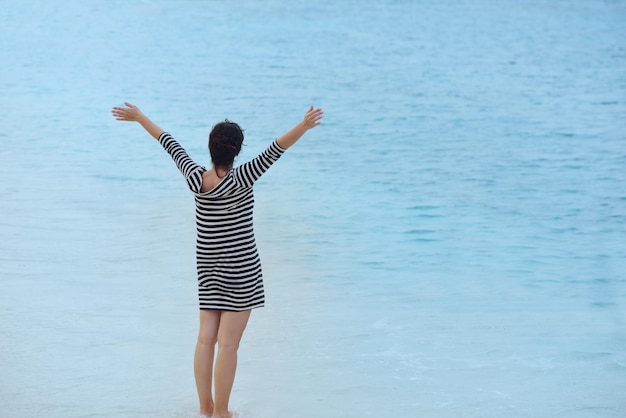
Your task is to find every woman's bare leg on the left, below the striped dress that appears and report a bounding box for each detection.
[193,310,221,416]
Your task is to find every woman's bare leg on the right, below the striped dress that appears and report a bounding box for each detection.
[213,310,250,418]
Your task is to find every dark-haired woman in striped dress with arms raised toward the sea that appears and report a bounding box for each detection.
[112,103,323,418]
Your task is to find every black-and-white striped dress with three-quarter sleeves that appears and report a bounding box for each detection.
[159,132,285,311]
